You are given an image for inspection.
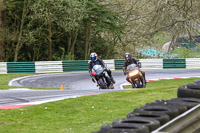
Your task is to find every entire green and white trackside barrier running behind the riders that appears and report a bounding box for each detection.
[0,58,200,74]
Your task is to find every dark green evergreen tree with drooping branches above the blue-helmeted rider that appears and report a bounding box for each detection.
[84,0,123,60]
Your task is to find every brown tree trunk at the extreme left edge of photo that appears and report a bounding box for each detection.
[0,0,4,61]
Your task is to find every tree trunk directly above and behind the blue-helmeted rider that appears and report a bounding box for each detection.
[85,24,90,60]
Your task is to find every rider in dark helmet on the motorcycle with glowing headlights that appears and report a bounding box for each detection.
[123,53,147,83]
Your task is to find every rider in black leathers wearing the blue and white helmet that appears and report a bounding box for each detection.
[89,53,115,83]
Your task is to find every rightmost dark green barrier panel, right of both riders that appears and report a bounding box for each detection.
[163,59,186,69]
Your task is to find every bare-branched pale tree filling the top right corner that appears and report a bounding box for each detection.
[145,0,200,49]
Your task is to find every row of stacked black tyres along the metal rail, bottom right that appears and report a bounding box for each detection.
[95,80,200,133]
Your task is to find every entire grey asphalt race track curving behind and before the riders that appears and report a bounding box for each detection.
[0,69,200,106]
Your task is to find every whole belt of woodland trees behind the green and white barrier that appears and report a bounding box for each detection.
[3,0,200,61]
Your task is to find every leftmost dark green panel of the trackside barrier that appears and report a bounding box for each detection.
[7,62,35,73]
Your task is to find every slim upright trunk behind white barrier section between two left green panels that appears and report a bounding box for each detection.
[48,22,52,61]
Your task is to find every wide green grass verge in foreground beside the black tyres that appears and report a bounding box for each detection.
[0,79,199,133]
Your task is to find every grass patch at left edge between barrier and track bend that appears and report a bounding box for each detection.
[0,73,69,90]
